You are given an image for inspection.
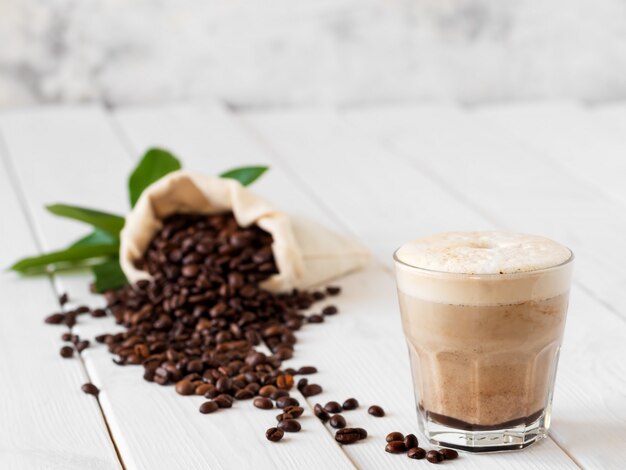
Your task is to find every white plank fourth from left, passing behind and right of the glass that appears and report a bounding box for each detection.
[244,108,626,468]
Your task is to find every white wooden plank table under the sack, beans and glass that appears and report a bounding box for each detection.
[0,103,626,470]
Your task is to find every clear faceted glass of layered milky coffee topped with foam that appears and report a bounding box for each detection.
[394,232,574,452]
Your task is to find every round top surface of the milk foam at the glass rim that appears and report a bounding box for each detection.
[396,232,571,274]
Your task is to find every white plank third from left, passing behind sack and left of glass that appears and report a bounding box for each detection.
[117,106,576,469]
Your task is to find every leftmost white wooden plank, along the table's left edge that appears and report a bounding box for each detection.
[0,127,120,470]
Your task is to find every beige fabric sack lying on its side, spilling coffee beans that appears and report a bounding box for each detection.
[120,170,369,292]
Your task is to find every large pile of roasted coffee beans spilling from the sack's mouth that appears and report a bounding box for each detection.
[46,213,341,441]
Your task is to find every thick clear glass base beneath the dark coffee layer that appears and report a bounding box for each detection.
[417,408,549,453]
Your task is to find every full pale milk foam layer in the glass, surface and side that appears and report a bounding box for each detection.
[395,232,572,305]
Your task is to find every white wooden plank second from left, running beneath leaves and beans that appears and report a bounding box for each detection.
[0,107,353,470]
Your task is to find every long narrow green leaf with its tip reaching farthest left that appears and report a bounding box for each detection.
[9,245,119,274]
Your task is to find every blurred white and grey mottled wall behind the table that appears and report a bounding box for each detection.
[0,0,626,107]
